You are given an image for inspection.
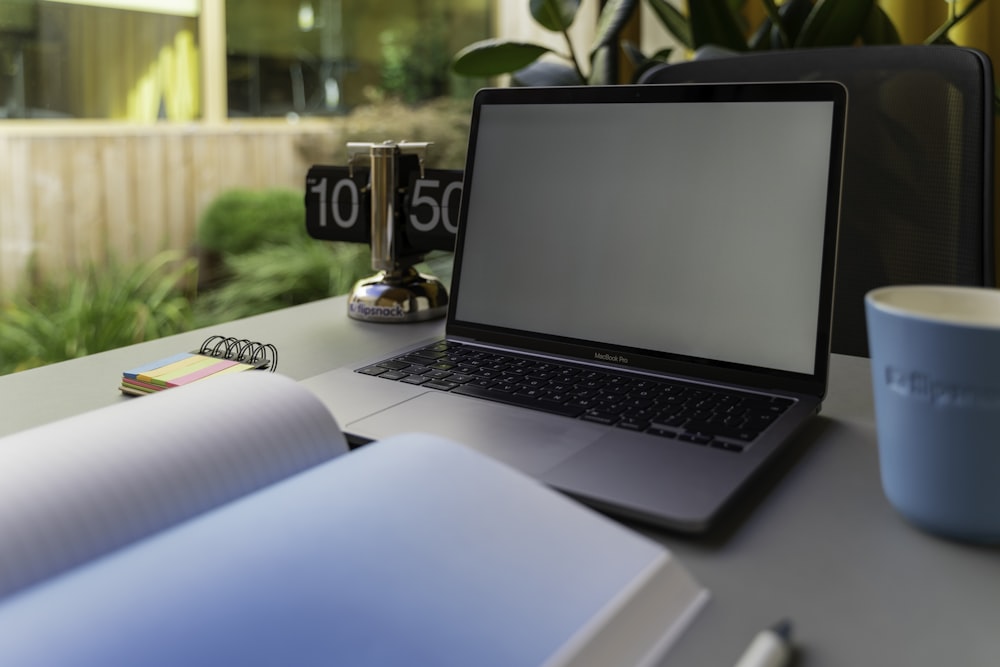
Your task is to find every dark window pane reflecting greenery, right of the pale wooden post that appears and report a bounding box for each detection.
[226,0,490,116]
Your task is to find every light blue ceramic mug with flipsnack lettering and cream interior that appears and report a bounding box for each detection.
[865,285,1000,543]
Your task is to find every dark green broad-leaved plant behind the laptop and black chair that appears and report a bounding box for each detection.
[452,0,1000,104]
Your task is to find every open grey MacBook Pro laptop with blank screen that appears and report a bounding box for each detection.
[305,82,846,533]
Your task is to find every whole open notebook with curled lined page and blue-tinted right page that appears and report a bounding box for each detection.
[0,373,708,667]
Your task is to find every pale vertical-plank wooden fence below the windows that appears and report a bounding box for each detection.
[0,120,343,300]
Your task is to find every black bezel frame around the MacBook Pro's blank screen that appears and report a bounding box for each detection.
[446,81,847,399]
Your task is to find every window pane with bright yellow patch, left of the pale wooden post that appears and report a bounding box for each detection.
[0,0,199,121]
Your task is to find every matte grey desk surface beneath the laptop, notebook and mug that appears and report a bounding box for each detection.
[0,297,1000,667]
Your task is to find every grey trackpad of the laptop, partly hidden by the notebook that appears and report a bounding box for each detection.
[343,391,606,477]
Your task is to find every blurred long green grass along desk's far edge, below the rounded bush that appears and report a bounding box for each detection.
[0,238,373,375]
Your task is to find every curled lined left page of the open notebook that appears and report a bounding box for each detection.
[0,372,347,598]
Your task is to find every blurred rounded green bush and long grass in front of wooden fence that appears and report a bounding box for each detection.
[0,189,372,374]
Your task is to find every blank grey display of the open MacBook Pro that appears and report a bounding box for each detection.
[450,84,843,386]
